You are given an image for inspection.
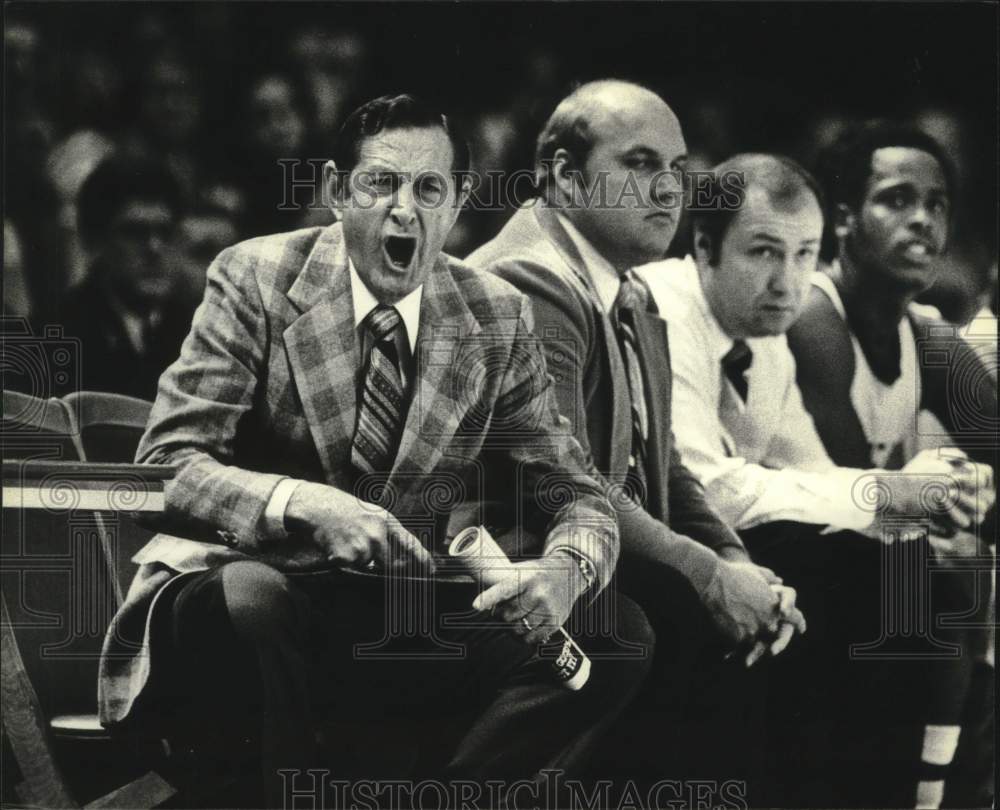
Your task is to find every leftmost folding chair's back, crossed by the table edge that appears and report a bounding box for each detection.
[0,391,119,718]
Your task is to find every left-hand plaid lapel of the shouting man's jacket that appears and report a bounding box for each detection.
[284,226,357,488]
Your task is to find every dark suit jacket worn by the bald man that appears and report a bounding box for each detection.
[467,202,746,593]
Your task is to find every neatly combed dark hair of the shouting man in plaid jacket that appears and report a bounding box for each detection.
[332,93,470,176]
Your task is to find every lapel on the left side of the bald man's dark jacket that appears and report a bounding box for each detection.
[524,202,632,473]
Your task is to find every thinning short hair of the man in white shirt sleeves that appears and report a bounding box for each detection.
[690,152,825,264]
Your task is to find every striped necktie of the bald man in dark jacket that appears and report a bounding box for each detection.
[613,270,650,503]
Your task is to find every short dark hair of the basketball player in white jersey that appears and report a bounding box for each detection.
[817,119,955,219]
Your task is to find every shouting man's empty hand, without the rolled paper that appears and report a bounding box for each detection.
[285,482,434,575]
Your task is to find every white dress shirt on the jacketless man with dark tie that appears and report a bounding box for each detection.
[638,257,874,531]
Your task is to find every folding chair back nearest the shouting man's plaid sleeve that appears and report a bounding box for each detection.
[63,391,153,593]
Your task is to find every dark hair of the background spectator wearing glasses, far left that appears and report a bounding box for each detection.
[76,154,182,245]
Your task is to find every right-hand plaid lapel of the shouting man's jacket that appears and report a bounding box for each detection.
[389,256,482,487]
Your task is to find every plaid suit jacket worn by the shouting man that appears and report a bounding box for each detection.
[99,225,618,724]
